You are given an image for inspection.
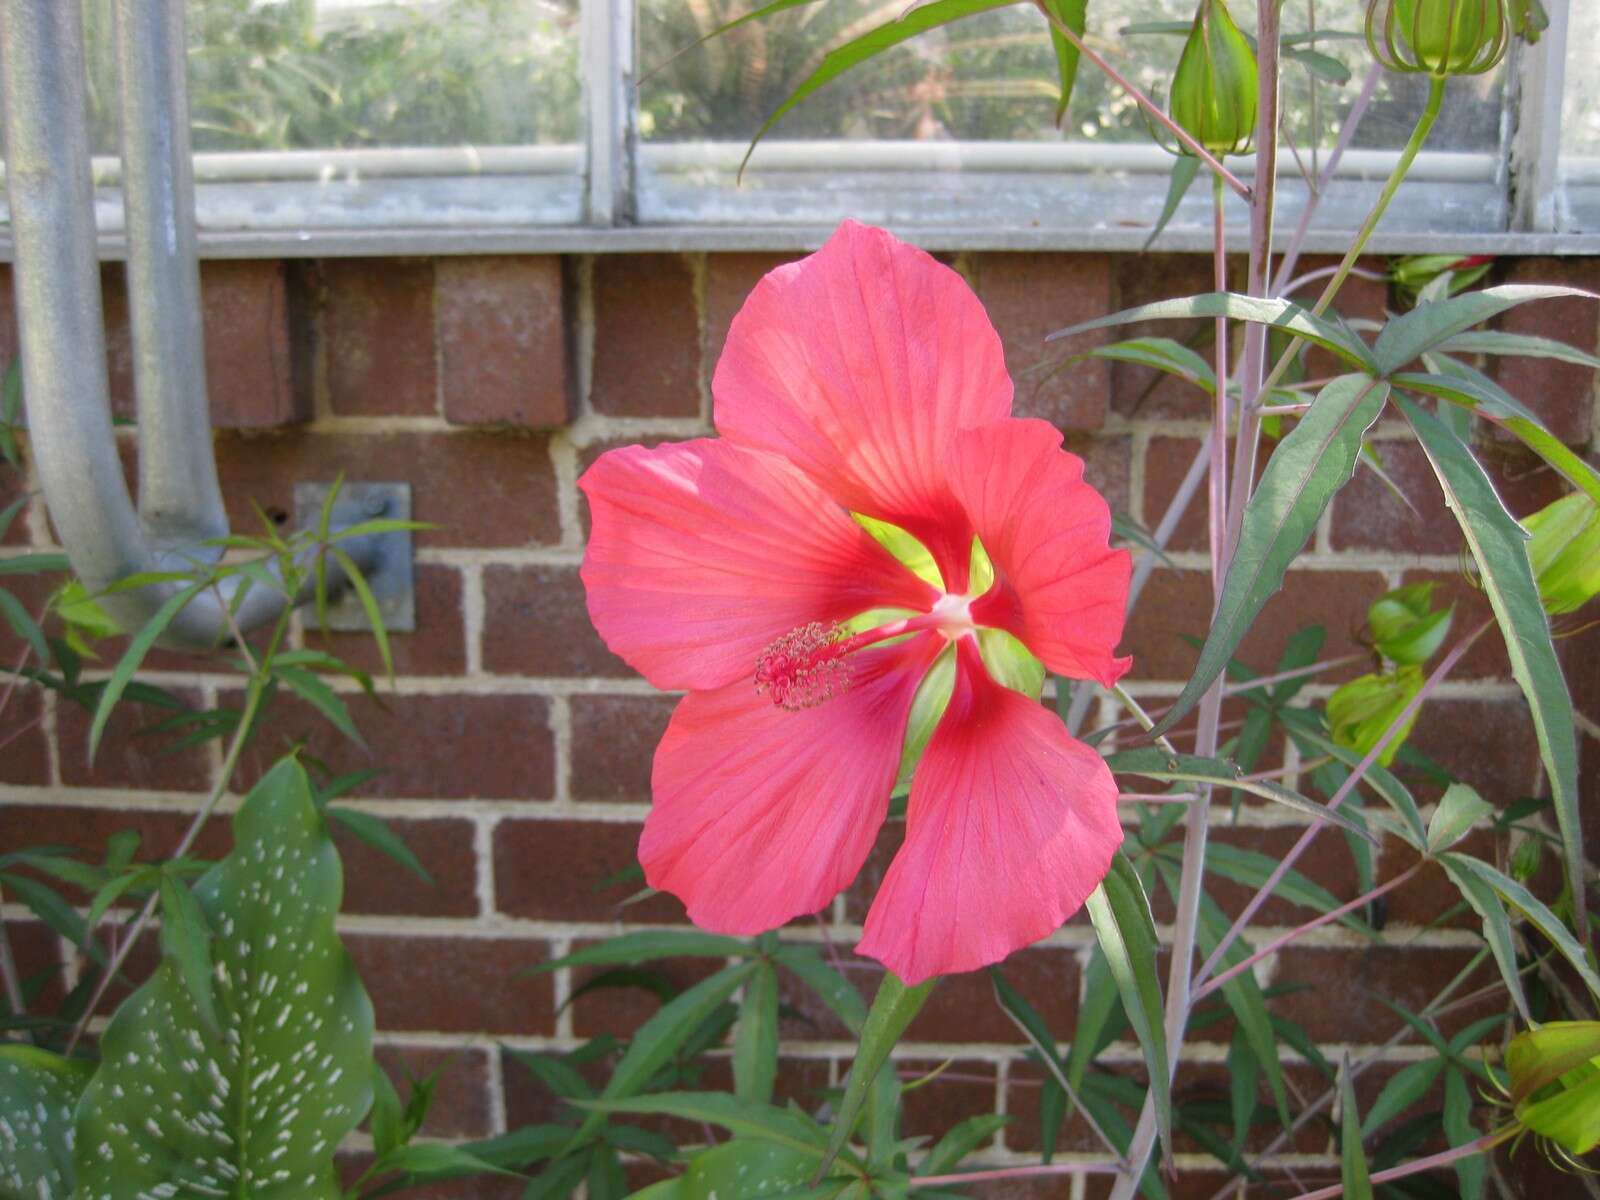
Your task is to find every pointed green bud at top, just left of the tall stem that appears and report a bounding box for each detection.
[1170,0,1258,155]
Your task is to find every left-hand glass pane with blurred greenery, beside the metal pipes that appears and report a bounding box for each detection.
[85,0,581,155]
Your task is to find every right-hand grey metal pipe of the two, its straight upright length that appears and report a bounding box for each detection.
[115,0,227,558]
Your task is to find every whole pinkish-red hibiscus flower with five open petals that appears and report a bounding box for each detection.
[579,222,1130,984]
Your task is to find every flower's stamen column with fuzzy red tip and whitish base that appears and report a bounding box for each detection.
[755,594,976,712]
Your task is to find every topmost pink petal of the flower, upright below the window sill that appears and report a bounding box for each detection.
[712,221,1011,590]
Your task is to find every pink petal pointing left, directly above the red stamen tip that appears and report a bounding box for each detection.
[578,438,934,688]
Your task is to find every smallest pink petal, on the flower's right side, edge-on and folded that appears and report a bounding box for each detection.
[949,419,1133,686]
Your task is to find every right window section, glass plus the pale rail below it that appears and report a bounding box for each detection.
[638,0,1504,232]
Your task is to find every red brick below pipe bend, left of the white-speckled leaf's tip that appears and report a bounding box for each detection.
[56,688,211,792]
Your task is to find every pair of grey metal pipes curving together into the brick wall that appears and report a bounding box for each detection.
[0,0,373,646]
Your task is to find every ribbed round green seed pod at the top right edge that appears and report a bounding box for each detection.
[1366,0,1528,78]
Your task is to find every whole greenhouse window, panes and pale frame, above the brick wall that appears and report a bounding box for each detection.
[12,0,1600,254]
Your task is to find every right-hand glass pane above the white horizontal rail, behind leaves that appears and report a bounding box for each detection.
[638,0,1502,153]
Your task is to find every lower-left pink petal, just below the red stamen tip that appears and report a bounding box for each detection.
[638,634,946,934]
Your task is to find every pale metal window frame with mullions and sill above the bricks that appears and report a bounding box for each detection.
[0,0,1600,261]
